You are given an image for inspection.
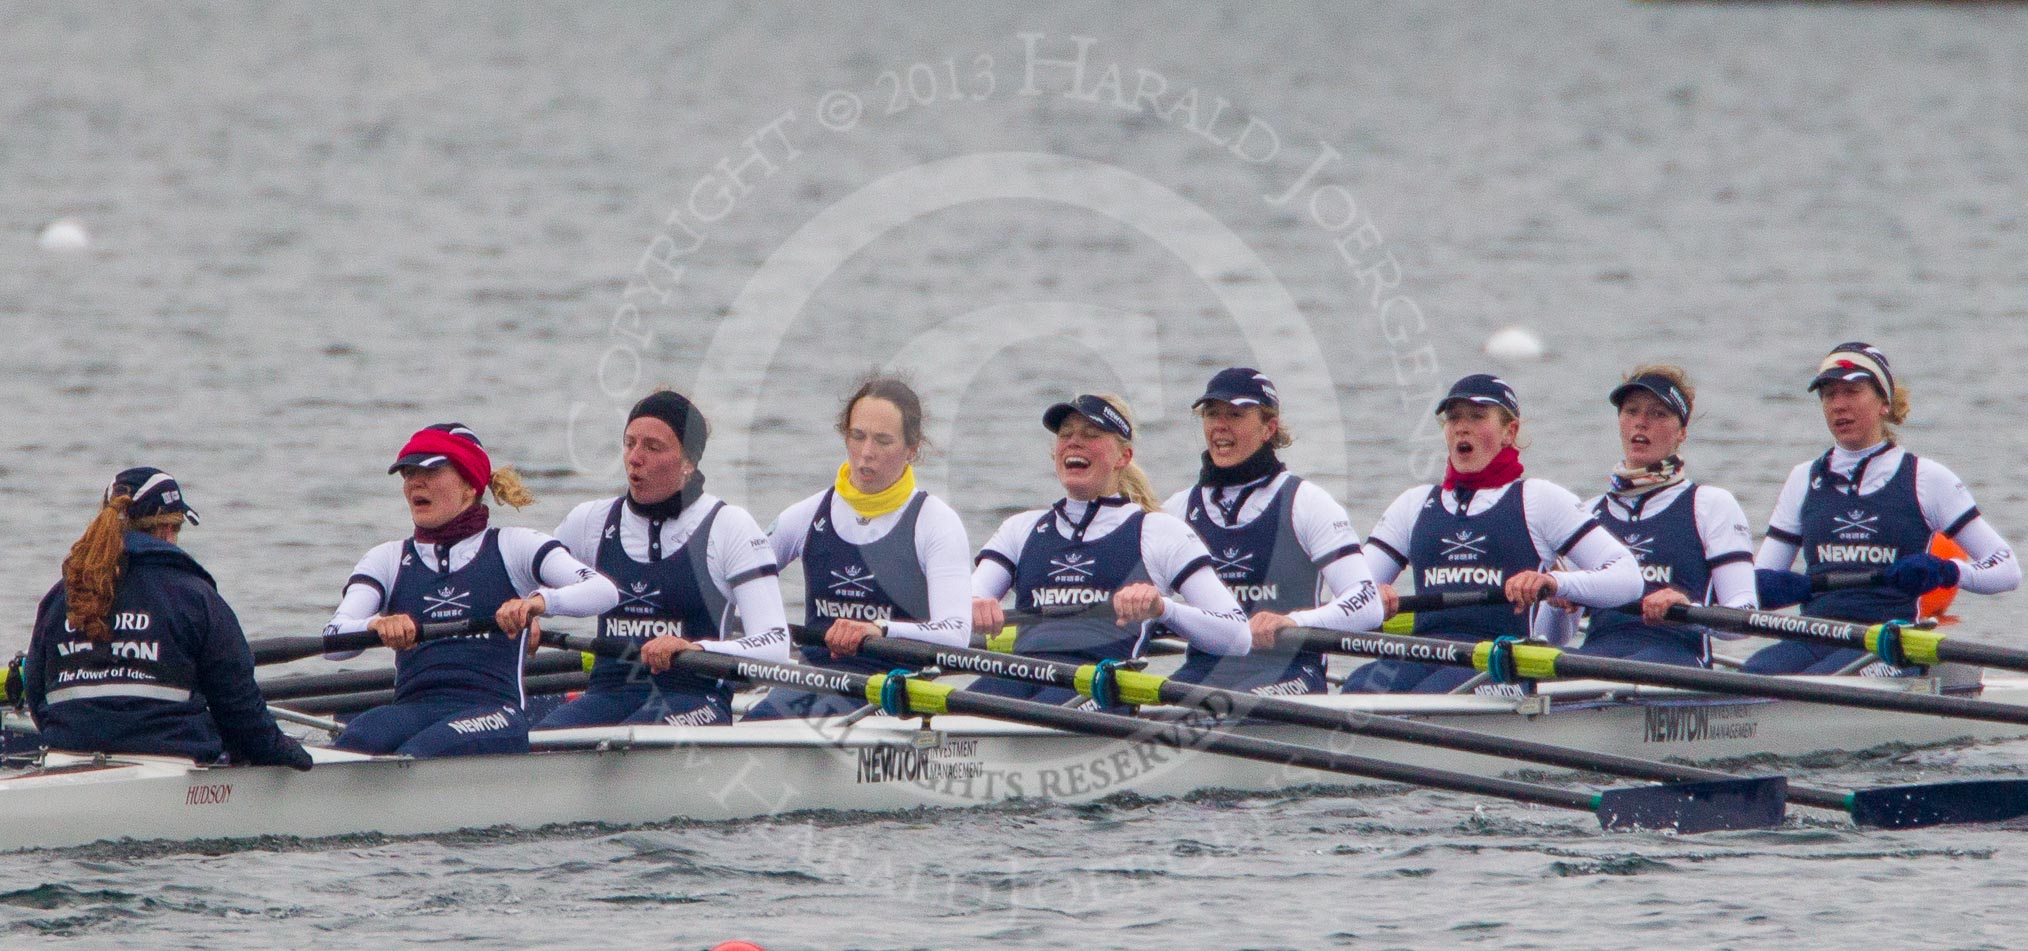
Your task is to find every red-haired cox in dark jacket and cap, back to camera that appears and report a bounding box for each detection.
[22,466,310,769]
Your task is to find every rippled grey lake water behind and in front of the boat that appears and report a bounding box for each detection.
[0,4,2028,947]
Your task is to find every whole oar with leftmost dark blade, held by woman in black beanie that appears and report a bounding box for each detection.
[541,631,1781,831]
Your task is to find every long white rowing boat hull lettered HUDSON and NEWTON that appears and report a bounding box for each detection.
[0,677,2028,850]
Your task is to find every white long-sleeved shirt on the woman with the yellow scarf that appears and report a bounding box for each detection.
[767,491,971,647]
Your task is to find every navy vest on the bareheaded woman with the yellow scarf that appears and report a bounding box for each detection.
[801,489,929,673]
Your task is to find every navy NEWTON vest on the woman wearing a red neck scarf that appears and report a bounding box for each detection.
[1407,481,1541,641]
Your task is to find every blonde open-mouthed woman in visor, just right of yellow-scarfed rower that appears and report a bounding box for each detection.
[971,393,1251,704]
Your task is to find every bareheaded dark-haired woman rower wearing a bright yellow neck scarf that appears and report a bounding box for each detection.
[746,377,971,720]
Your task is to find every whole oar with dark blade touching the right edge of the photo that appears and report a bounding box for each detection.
[949,624,2028,829]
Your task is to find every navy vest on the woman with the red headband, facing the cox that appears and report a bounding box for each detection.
[381,529,523,708]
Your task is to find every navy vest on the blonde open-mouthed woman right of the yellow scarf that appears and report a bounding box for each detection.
[1014,501,1150,661]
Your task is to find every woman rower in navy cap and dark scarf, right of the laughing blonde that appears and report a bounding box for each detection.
[1162,367,1385,693]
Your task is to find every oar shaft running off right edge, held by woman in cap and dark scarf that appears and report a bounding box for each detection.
[1282,627,2028,724]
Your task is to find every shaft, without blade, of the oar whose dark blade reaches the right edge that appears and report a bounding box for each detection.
[791,627,1792,811]
